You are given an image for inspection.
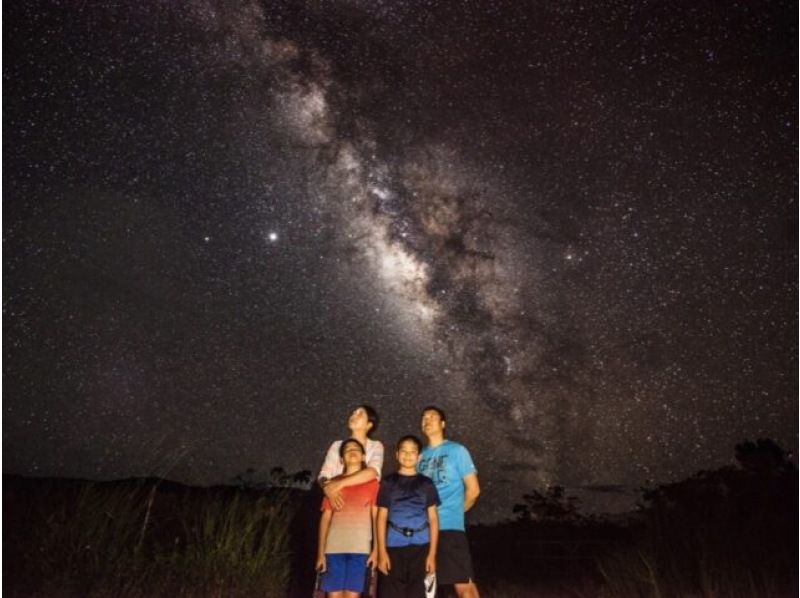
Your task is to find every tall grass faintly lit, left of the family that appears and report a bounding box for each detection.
[3,482,292,598]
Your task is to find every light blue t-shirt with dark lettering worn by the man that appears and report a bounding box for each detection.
[417,440,478,531]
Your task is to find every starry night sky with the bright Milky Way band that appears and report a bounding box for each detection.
[2,0,798,521]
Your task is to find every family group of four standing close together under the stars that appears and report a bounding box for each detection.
[316,405,480,598]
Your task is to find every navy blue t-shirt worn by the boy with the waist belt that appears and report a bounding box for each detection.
[378,473,439,548]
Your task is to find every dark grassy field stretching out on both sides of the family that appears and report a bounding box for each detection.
[3,458,798,598]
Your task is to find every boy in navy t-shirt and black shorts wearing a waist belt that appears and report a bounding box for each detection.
[377,436,439,598]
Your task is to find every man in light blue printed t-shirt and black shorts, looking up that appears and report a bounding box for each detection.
[417,406,480,598]
